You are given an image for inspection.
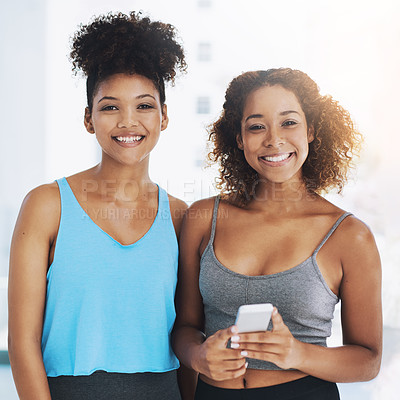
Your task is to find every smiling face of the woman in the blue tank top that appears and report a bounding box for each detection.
[85,74,168,165]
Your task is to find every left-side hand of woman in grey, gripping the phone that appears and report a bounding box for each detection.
[193,326,247,381]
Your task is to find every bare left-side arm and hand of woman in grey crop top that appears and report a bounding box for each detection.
[173,199,246,396]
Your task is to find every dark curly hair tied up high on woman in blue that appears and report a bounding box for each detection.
[70,11,186,111]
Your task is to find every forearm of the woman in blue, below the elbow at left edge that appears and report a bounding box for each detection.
[9,343,51,400]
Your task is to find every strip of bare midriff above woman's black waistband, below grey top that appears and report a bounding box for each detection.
[200,369,307,389]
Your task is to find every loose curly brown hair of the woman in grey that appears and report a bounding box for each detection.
[208,68,362,204]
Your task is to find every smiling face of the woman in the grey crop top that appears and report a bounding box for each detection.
[237,85,314,188]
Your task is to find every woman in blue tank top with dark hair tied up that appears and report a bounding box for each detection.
[9,12,190,400]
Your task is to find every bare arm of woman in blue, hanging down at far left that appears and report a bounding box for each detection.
[8,184,60,400]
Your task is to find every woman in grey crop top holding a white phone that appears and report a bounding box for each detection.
[173,68,382,400]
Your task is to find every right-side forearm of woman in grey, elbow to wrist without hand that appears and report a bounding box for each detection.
[295,342,381,382]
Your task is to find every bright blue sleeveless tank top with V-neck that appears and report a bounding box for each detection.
[42,178,179,377]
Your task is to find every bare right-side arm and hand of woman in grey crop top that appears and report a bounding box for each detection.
[236,218,382,382]
